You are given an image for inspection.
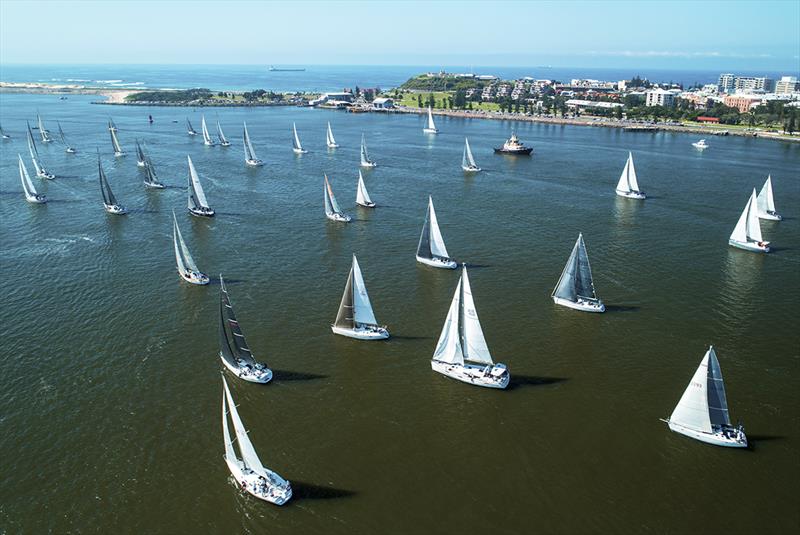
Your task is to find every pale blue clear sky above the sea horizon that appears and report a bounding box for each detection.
[0,0,800,73]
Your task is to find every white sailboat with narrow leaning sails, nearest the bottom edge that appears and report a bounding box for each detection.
[222,377,292,505]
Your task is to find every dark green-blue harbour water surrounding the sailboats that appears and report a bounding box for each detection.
[0,90,800,534]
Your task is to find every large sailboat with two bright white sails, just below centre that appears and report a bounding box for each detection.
[431,265,510,388]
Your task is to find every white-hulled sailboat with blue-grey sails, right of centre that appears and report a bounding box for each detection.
[552,234,606,312]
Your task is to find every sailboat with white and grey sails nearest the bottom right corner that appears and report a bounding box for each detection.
[662,346,747,448]
